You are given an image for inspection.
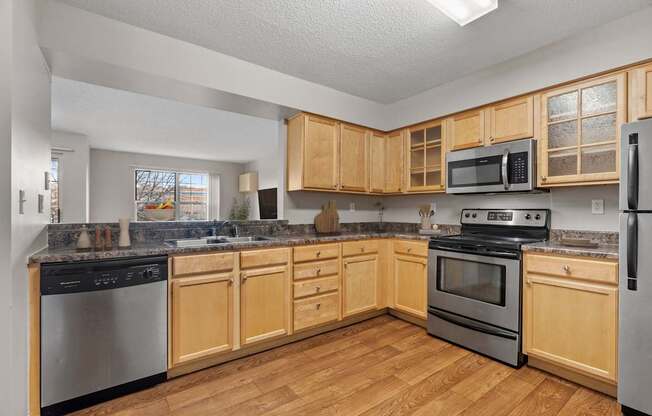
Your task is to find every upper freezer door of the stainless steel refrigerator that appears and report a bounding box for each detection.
[620,120,652,211]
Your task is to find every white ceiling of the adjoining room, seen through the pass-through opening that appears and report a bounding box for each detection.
[52,77,278,162]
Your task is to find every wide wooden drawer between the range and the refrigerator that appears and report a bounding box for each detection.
[525,254,618,284]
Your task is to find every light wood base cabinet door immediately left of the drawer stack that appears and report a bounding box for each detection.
[240,266,291,345]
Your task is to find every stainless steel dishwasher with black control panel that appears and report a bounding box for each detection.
[41,256,168,416]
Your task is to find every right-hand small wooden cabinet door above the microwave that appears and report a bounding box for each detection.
[487,96,534,144]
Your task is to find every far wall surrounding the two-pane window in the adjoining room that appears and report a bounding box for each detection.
[90,149,244,222]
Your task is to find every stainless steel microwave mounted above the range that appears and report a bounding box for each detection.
[446,139,537,194]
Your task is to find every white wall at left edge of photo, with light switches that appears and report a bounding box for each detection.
[0,0,50,415]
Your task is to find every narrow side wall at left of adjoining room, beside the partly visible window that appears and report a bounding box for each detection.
[52,130,90,223]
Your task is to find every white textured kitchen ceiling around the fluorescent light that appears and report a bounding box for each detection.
[60,0,652,103]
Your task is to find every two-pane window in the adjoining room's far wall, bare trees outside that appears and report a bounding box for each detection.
[134,169,208,221]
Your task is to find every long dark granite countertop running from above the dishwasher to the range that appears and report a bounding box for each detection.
[29,232,438,264]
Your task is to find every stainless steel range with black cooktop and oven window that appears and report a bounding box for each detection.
[428,209,550,367]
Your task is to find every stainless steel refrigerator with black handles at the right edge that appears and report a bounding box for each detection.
[618,119,652,415]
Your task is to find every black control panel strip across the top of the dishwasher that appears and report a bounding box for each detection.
[41,256,168,295]
